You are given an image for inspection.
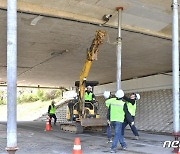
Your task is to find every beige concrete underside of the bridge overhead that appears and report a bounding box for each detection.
[0,0,177,86]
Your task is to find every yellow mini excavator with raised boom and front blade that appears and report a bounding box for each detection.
[60,30,107,133]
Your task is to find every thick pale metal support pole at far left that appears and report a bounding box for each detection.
[6,0,18,154]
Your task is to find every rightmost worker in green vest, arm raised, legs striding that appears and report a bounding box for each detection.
[122,93,140,140]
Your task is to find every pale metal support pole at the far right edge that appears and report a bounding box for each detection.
[172,0,180,152]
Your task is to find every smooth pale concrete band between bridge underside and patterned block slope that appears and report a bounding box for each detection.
[94,74,172,95]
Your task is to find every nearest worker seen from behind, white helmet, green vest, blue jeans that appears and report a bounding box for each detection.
[106,89,134,153]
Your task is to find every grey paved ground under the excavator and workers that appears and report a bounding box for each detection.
[0,122,173,154]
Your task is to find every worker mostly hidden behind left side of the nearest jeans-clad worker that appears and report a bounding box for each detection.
[104,91,116,143]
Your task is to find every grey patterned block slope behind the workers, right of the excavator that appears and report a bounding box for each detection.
[97,89,173,133]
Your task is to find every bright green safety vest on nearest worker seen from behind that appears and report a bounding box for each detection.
[106,98,125,122]
